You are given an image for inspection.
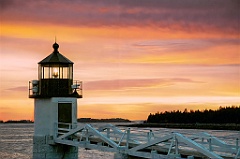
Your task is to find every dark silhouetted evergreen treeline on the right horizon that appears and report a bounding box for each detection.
[147,106,240,124]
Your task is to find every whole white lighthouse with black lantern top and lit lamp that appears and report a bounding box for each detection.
[29,42,82,159]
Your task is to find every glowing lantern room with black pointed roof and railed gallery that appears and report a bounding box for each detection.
[29,42,81,98]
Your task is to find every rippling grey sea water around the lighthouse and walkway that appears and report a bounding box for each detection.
[0,123,240,159]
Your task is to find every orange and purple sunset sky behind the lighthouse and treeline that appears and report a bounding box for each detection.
[0,0,240,121]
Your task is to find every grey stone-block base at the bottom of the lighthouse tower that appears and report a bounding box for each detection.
[33,136,78,159]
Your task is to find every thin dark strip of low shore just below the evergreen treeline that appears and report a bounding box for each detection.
[117,123,240,131]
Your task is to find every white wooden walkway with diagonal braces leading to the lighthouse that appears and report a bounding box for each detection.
[52,123,240,159]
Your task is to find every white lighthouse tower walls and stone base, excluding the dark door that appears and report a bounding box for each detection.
[33,97,78,159]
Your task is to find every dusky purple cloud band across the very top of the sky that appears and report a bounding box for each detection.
[1,0,239,34]
